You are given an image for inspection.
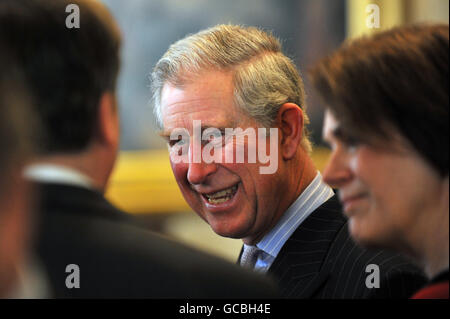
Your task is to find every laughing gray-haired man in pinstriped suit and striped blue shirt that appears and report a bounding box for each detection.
[152,25,424,298]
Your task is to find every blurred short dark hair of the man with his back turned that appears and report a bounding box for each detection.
[0,0,121,153]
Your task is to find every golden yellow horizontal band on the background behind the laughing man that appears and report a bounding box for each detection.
[106,148,329,214]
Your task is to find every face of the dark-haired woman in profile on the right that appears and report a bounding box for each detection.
[323,111,443,250]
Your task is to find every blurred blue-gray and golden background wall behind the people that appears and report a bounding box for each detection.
[103,0,449,260]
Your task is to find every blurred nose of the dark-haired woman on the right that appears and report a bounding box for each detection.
[323,150,353,188]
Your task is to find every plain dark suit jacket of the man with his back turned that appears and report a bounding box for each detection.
[36,184,276,298]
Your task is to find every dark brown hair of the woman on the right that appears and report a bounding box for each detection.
[311,24,449,176]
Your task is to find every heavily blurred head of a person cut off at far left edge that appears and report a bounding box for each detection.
[0,51,37,298]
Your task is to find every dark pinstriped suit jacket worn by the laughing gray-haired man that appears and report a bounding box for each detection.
[239,196,426,299]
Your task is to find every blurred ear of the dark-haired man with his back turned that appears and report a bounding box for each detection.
[97,92,120,146]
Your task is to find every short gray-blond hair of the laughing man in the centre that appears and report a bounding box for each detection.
[151,25,311,152]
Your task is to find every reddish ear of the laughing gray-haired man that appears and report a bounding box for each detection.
[277,103,304,160]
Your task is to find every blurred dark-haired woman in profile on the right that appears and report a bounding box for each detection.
[311,25,449,298]
